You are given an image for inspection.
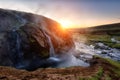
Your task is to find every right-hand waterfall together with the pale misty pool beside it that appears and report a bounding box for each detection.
[44,30,89,67]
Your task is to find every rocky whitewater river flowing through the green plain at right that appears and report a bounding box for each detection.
[75,42,120,61]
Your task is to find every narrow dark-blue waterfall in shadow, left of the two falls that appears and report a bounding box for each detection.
[11,31,24,68]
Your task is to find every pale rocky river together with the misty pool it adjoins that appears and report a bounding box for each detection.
[54,36,120,67]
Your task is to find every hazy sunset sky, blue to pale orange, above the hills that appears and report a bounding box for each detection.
[0,0,120,28]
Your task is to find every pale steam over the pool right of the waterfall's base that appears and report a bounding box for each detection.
[57,49,89,67]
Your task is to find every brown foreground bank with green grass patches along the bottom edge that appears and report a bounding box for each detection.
[0,56,120,80]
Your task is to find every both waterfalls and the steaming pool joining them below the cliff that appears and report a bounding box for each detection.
[9,17,89,70]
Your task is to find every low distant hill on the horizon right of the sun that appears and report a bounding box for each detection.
[69,23,120,34]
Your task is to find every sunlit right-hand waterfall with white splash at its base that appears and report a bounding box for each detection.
[36,17,61,66]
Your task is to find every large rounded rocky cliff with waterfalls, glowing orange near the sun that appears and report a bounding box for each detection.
[0,9,74,68]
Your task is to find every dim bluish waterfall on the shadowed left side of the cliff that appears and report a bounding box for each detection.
[8,30,23,68]
